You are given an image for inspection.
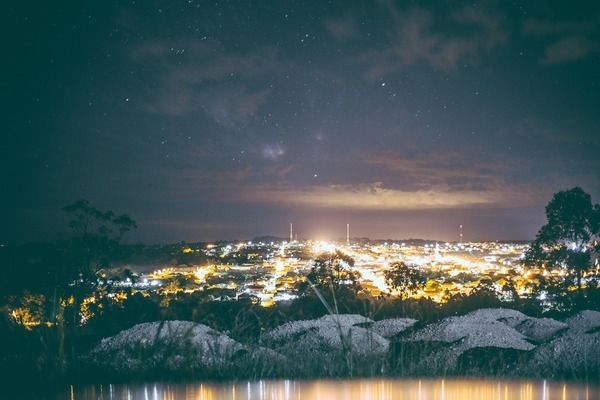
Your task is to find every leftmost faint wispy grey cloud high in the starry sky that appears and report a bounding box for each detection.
[130,39,281,128]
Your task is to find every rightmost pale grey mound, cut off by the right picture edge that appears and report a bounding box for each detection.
[529,310,600,377]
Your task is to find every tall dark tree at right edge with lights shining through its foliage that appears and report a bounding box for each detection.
[525,187,600,289]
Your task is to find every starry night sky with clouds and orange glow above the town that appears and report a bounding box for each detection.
[0,0,600,243]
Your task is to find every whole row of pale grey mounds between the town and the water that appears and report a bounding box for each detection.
[87,308,600,379]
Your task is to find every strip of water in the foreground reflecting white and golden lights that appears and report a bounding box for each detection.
[61,379,600,400]
